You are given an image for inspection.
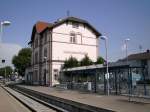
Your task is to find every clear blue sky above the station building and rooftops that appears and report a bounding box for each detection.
[0,0,150,61]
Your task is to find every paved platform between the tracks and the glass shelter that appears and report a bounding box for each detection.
[19,85,150,112]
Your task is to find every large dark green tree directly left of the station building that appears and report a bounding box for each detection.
[12,48,31,76]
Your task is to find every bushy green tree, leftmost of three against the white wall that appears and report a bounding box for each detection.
[64,56,79,68]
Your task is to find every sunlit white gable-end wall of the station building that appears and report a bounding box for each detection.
[52,23,98,85]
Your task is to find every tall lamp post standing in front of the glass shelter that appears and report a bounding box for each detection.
[100,36,109,96]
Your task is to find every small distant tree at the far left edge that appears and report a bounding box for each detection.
[0,66,13,77]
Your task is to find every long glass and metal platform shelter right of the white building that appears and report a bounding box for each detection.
[60,66,150,96]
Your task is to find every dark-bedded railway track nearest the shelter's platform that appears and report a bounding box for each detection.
[7,86,114,112]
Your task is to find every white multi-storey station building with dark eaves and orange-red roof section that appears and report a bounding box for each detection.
[28,17,101,86]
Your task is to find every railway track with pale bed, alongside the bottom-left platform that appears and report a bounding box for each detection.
[3,87,68,112]
